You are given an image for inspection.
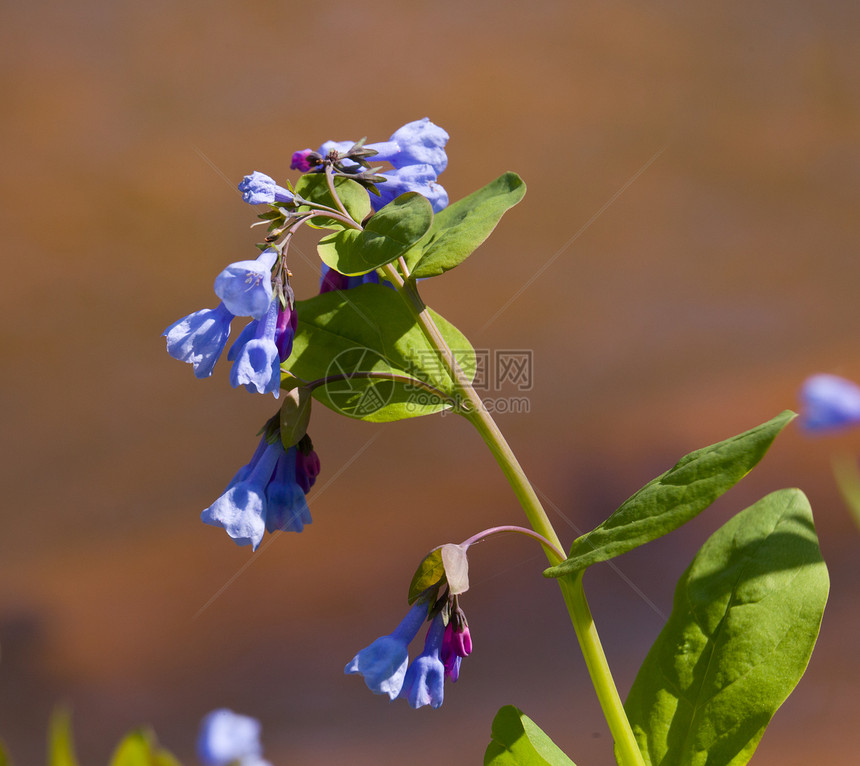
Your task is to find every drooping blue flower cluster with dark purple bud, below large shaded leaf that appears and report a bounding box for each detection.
[200,435,320,550]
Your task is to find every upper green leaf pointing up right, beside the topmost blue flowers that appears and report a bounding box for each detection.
[404,173,526,279]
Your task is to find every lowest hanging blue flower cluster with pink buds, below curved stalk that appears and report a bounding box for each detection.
[344,598,472,710]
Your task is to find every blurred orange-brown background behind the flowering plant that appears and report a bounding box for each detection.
[0,0,860,766]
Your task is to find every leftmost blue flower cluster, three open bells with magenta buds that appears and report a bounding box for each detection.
[162,248,296,399]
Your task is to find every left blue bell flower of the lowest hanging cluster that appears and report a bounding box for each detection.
[343,599,430,700]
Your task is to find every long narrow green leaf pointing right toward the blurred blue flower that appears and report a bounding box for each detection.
[544,410,796,577]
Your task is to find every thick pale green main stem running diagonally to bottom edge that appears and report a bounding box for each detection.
[382,264,645,766]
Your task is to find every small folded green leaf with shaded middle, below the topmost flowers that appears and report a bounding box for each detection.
[317,192,433,276]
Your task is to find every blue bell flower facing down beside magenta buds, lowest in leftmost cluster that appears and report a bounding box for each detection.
[227,298,281,399]
